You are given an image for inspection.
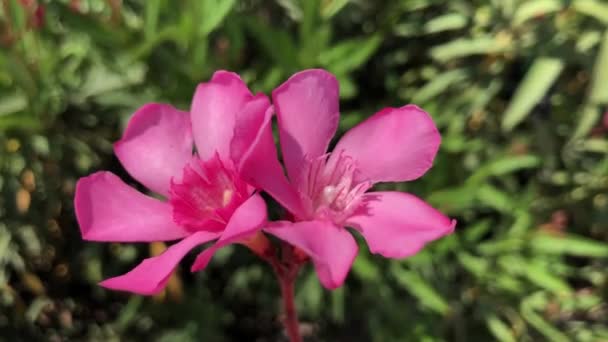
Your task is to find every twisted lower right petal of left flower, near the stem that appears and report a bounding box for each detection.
[191,194,266,272]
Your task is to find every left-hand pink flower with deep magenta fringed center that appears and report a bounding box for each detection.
[75,71,271,295]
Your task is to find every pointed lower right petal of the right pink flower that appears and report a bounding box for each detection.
[347,192,456,258]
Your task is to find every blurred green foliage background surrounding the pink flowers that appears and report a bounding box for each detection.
[0,0,608,341]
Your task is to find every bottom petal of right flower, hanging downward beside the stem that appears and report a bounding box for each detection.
[264,221,359,289]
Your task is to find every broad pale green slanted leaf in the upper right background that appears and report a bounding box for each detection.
[502,57,564,132]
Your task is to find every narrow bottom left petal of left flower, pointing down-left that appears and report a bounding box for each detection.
[99,231,219,295]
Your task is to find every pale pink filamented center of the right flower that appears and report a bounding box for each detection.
[298,152,371,223]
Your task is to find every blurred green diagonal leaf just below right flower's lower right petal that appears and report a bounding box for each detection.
[391,264,450,315]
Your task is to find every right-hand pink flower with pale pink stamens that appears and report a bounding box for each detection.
[241,70,456,289]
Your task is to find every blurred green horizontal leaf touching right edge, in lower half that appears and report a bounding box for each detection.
[530,233,608,258]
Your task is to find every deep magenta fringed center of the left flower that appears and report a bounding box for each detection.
[169,156,248,231]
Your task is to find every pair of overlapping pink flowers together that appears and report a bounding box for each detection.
[75,69,455,295]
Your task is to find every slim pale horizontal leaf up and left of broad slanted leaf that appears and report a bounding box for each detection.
[431,37,511,62]
